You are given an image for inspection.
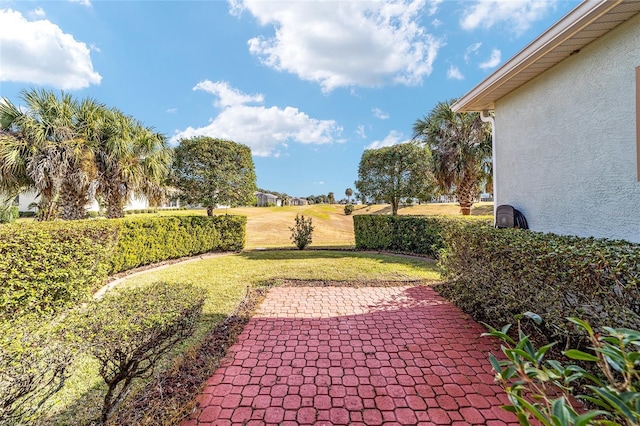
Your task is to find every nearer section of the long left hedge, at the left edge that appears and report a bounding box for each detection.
[0,221,117,320]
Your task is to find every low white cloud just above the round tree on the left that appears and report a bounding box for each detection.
[171,80,342,157]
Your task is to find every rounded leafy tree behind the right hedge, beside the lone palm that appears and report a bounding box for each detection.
[355,143,433,215]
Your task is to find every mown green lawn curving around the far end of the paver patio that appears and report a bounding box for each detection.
[44,251,439,424]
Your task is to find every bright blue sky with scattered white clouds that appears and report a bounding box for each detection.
[0,0,579,198]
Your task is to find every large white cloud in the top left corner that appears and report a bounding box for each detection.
[0,9,102,90]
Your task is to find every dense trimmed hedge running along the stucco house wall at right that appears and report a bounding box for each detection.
[439,222,640,344]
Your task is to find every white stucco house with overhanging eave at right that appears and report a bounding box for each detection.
[452,0,640,243]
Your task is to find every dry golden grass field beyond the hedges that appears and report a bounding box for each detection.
[152,203,493,249]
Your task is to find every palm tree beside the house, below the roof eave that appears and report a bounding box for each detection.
[413,99,491,215]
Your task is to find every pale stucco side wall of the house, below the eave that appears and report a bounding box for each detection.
[494,15,640,243]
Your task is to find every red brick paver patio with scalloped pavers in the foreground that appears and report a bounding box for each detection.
[183,287,518,426]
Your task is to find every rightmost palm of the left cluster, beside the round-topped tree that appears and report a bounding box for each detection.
[95,109,171,218]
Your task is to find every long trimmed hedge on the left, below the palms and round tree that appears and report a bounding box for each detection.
[0,215,246,320]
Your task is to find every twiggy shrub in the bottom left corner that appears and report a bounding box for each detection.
[0,317,73,424]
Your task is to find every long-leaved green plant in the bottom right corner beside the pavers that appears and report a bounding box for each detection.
[485,312,640,426]
